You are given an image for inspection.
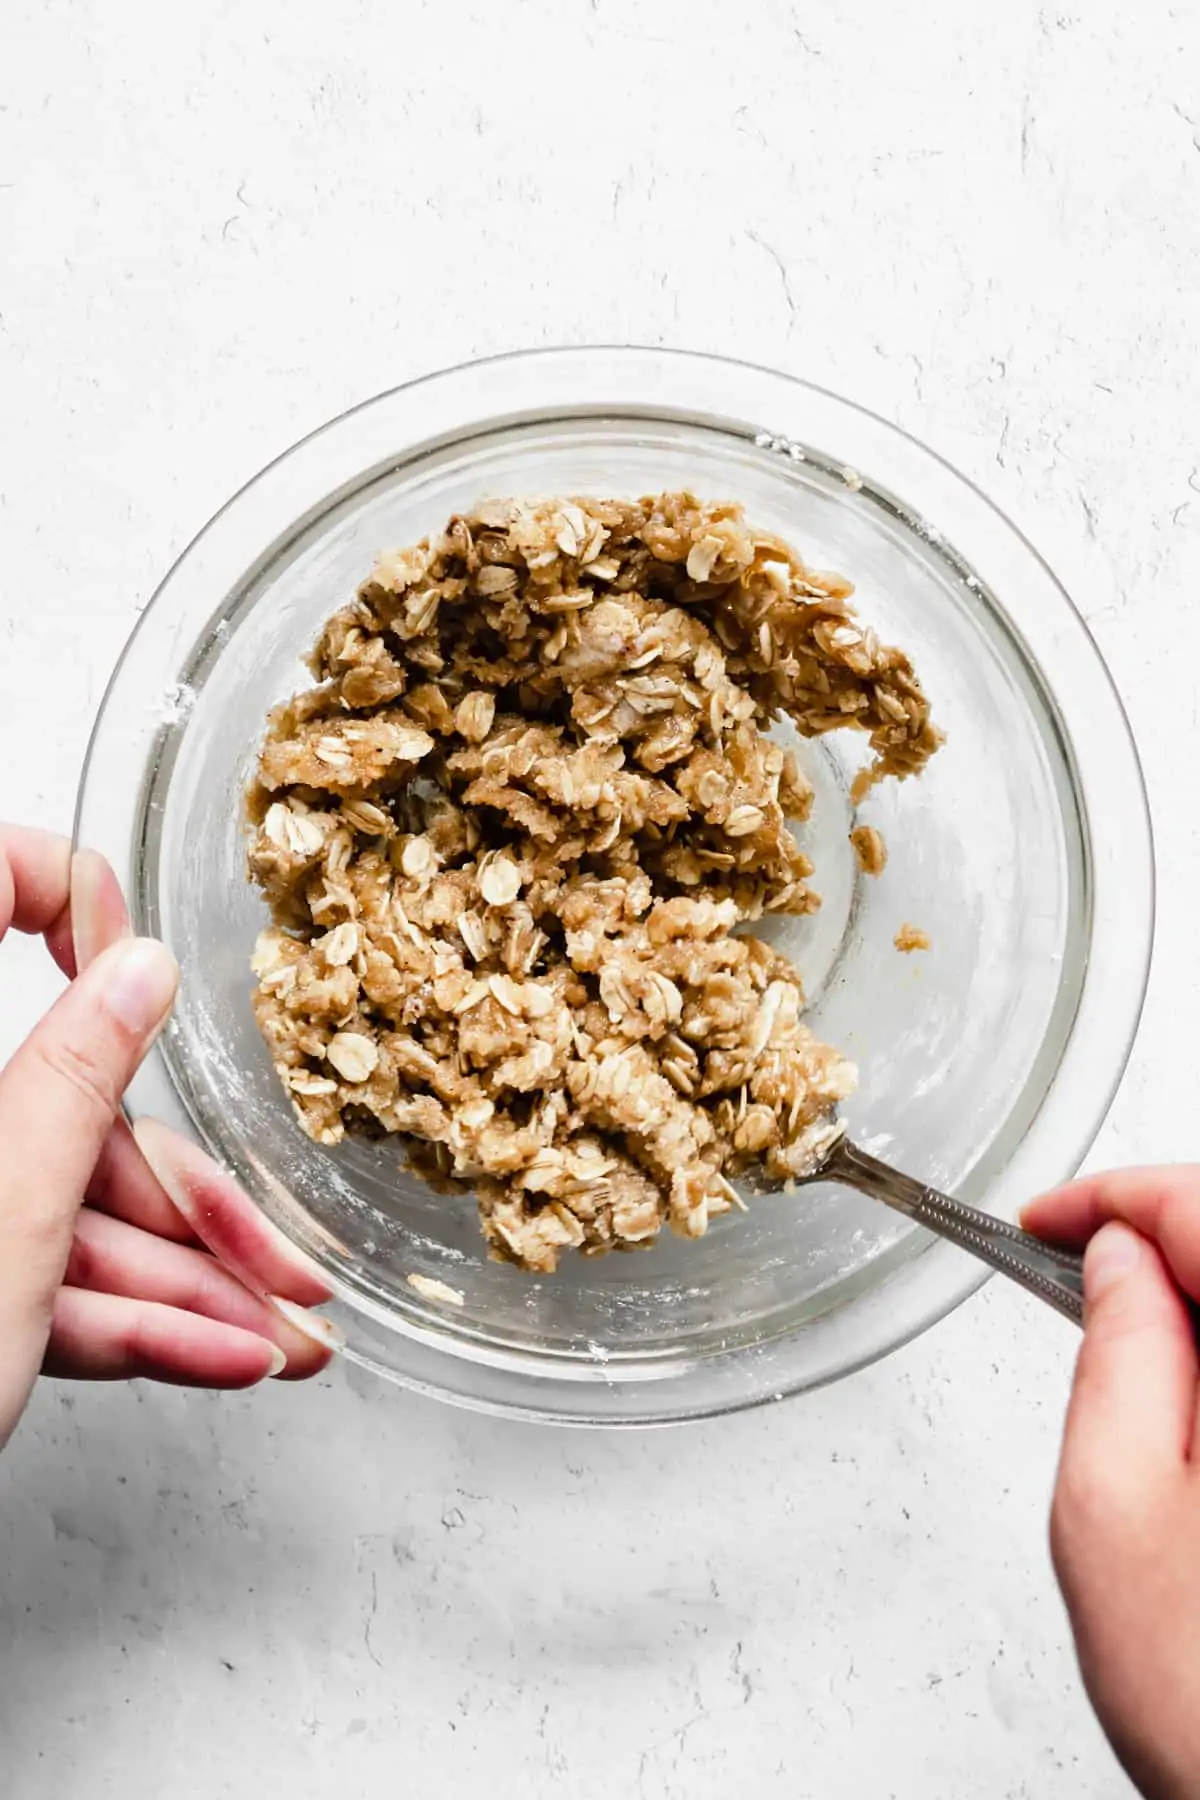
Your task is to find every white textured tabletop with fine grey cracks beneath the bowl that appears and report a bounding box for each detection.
[0,0,1200,1800]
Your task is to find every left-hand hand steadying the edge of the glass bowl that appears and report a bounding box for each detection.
[0,826,338,1449]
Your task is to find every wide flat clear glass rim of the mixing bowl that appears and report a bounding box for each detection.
[76,346,1155,1424]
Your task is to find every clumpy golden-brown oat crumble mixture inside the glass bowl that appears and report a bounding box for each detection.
[241,493,941,1271]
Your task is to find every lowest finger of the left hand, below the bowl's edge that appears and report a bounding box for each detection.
[43,1287,284,1388]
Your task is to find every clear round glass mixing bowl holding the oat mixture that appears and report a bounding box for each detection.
[77,349,1153,1424]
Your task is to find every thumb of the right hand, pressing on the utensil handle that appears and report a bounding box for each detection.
[1060,1224,1196,1508]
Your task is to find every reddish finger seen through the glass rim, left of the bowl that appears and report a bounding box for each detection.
[133,1120,329,1307]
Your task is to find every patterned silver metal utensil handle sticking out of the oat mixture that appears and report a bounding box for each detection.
[819,1138,1083,1325]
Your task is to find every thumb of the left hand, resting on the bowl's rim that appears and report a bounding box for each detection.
[0,938,178,1386]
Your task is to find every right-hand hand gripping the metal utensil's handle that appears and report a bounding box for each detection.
[1022,1166,1200,1800]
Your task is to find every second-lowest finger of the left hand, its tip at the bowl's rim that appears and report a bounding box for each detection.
[63,1208,331,1381]
